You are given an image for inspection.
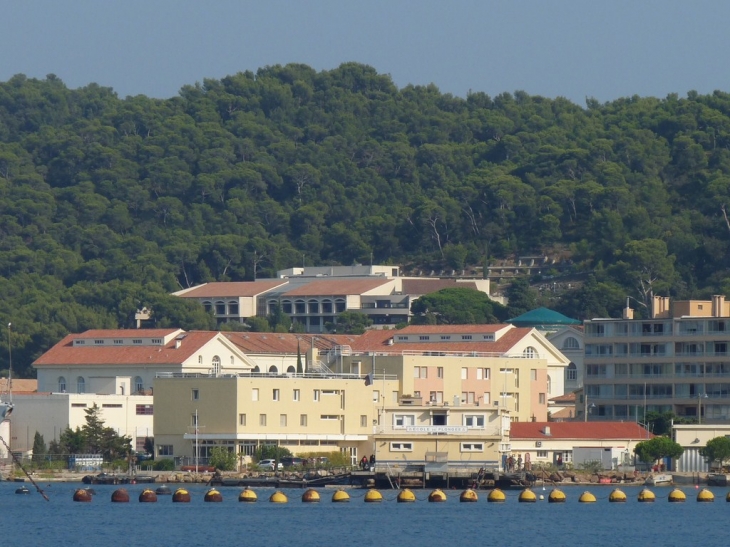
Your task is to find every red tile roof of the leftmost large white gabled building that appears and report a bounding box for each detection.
[33,329,218,367]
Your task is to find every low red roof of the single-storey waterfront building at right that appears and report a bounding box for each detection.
[510,422,654,440]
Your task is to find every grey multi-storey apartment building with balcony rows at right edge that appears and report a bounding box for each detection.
[577,295,730,421]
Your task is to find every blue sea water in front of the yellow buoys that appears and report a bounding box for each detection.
[0,482,730,547]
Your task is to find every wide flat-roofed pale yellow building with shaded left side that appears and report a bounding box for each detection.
[154,373,398,464]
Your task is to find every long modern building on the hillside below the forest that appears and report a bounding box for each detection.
[173,265,489,333]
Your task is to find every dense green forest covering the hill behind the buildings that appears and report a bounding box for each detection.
[0,63,730,374]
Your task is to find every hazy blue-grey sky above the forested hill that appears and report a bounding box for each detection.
[0,0,730,105]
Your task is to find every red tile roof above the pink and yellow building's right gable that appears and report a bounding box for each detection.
[352,325,532,354]
